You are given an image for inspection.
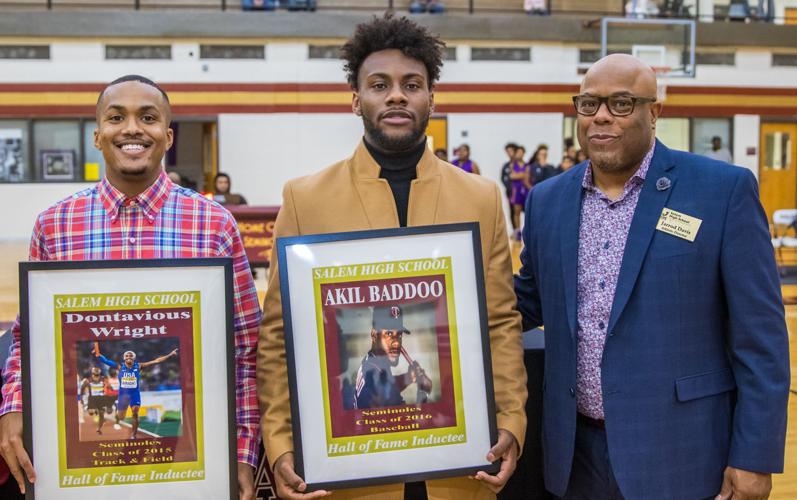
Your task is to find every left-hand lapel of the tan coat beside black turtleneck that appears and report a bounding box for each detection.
[349,141,399,229]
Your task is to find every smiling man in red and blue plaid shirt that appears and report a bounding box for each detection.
[0,75,261,500]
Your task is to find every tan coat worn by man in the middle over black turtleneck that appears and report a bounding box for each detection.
[257,142,526,500]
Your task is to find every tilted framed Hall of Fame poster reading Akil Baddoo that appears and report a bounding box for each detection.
[277,223,498,491]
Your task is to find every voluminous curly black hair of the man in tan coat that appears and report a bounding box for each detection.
[341,12,446,90]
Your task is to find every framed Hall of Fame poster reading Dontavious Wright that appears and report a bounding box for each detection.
[20,257,238,500]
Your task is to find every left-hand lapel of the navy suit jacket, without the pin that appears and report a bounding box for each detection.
[559,164,588,336]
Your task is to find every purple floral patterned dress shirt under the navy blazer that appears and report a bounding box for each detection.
[576,143,655,420]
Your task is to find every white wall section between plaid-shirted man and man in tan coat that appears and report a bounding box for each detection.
[219,113,363,205]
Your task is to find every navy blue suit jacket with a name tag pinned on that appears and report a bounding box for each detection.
[515,142,789,499]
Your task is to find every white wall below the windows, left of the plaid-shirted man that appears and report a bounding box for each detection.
[0,183,94,241]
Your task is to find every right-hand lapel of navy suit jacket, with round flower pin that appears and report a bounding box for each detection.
[606,141,677,332]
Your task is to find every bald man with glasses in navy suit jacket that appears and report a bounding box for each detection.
[515,54,789,500]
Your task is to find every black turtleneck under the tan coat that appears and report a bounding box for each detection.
[364,139,426,227]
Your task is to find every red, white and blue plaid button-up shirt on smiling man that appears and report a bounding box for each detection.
[0,172,261,467]
